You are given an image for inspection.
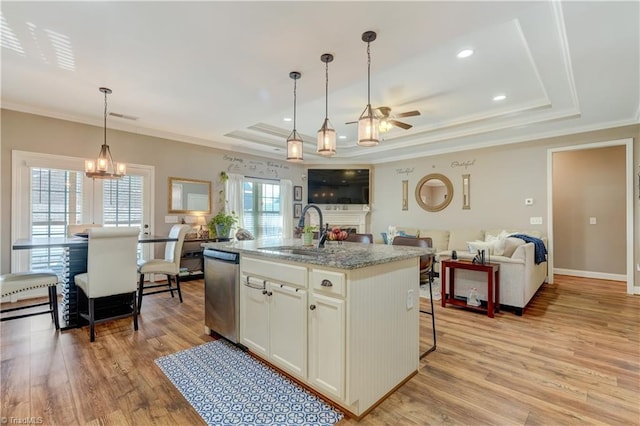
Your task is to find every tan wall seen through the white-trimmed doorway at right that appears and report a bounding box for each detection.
[553,146,627,275]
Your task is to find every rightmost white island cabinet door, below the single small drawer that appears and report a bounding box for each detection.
[308,292,345,400]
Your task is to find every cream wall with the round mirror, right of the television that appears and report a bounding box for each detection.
[371,125,640,285]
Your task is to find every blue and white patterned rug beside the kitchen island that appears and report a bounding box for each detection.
[156,339,343,426]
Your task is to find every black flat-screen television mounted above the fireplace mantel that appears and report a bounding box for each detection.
[307,169,369,204]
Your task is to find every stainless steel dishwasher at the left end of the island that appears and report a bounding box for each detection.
[203,249,240,344]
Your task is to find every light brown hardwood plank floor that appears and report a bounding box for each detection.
[0,276,640,425]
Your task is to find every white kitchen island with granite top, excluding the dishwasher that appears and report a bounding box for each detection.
[203,239,430,418]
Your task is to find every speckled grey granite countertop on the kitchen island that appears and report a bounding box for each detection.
[202,238,434,269]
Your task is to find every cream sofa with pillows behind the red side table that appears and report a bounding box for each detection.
[397,227,547,315]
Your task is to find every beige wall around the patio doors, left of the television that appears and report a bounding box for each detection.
[0,110,306,273]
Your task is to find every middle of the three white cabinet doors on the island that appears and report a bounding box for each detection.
[267,282,307,378]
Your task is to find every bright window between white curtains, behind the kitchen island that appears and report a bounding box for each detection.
[242,178,283,238]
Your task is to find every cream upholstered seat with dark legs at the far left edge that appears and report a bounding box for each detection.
[0,270,60,330]
